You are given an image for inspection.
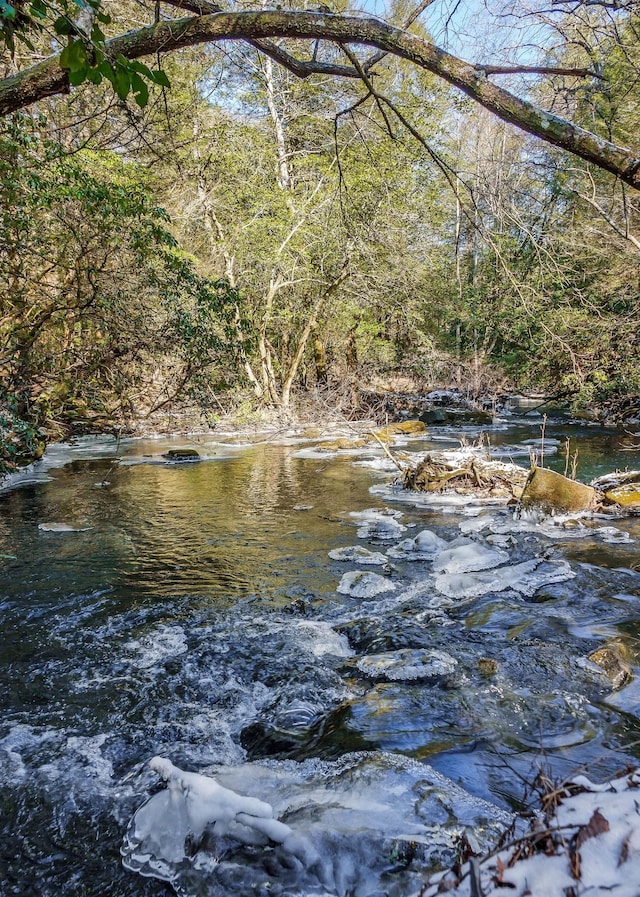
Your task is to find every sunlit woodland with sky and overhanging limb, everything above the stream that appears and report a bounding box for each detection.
[0,0,640,469]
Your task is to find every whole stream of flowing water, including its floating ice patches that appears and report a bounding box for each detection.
[0,419,640,897]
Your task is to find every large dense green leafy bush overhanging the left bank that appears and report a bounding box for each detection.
[0,117,241,462]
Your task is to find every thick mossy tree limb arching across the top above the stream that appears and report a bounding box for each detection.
[0,10,640,190]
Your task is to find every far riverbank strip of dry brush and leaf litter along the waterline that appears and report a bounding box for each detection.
[5,382,640,476]
